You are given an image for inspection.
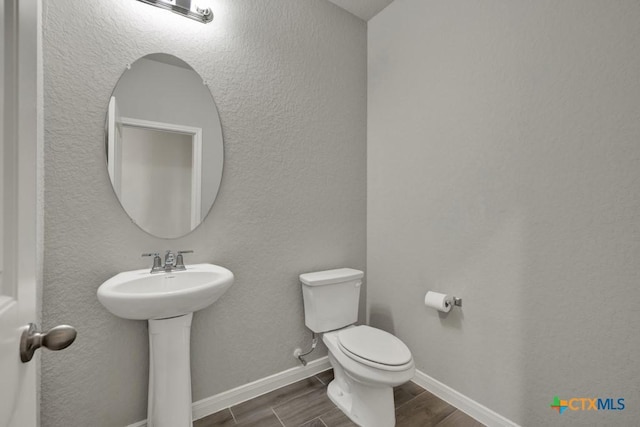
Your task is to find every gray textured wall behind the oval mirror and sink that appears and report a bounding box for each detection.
[42,0,366,427]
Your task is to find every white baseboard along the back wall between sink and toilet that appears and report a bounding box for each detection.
[127,356,331,427]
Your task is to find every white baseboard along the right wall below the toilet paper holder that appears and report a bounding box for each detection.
[412,369,520,427]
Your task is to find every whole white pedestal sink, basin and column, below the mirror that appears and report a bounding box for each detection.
[98,264,233,427]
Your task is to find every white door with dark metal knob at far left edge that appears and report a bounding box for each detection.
[0,0,42,427]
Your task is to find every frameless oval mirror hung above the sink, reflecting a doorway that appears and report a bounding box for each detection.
[105,53,224,238]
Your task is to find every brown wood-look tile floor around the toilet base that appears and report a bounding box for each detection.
[193,370,483,427]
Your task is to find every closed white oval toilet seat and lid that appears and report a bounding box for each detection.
[337,325,413,371]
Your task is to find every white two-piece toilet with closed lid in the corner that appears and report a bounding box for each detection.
[300,268,415,427]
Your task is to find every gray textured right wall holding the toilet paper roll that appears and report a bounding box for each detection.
[367,0,640,426]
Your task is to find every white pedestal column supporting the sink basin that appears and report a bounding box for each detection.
[147,313,193,427]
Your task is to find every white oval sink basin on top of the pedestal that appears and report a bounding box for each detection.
[98,264,233,320]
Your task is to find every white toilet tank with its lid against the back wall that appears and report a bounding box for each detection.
[300,268,364,333]
